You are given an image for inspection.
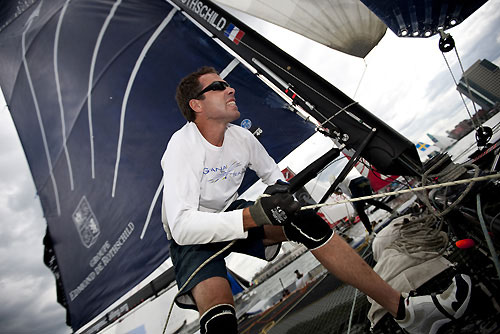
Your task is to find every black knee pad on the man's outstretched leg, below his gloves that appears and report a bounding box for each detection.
[283,210,333,250]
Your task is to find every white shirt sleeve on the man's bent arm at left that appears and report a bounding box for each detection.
[161,131,248,245]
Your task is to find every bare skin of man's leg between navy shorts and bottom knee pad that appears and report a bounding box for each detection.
[191,276,234,316]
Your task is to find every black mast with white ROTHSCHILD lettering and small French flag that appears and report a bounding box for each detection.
[167,0,421,175]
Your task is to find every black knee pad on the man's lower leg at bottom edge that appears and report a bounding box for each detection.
[200,304,238,334]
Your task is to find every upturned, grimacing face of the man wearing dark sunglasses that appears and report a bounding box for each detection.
[197,73,240,123]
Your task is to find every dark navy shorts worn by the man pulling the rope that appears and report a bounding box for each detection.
[170,200,281,310]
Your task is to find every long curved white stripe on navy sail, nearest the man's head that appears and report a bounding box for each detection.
[111,8,177,197]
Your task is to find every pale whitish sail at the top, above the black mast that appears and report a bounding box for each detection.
[215,0,387,58]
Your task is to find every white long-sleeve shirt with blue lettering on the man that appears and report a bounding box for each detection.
[161,122,283,245]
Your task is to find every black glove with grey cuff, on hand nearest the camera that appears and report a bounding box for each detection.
[249,190,300,226]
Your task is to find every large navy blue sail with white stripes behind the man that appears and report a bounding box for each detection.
[0,0,313,330]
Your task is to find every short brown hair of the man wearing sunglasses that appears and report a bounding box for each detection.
[175,66,219,122]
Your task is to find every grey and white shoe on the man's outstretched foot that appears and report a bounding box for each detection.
[396,274,471,334]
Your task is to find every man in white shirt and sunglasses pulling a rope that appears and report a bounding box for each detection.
[162,67,471,334]
